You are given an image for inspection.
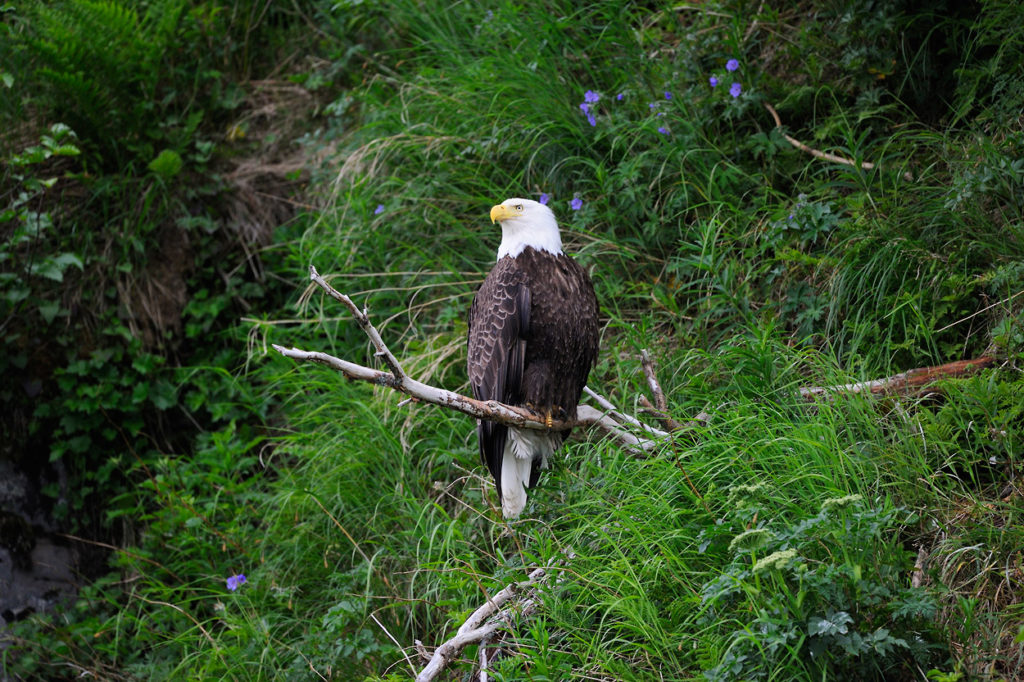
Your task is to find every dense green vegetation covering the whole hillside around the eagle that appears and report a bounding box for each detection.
[0,0,1024,680]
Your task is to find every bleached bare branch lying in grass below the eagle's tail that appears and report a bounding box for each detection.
[416,568,548,682]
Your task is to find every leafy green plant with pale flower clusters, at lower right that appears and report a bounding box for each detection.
[701,495,941,680]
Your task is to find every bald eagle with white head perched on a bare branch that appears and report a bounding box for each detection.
[468,199,598,518]
